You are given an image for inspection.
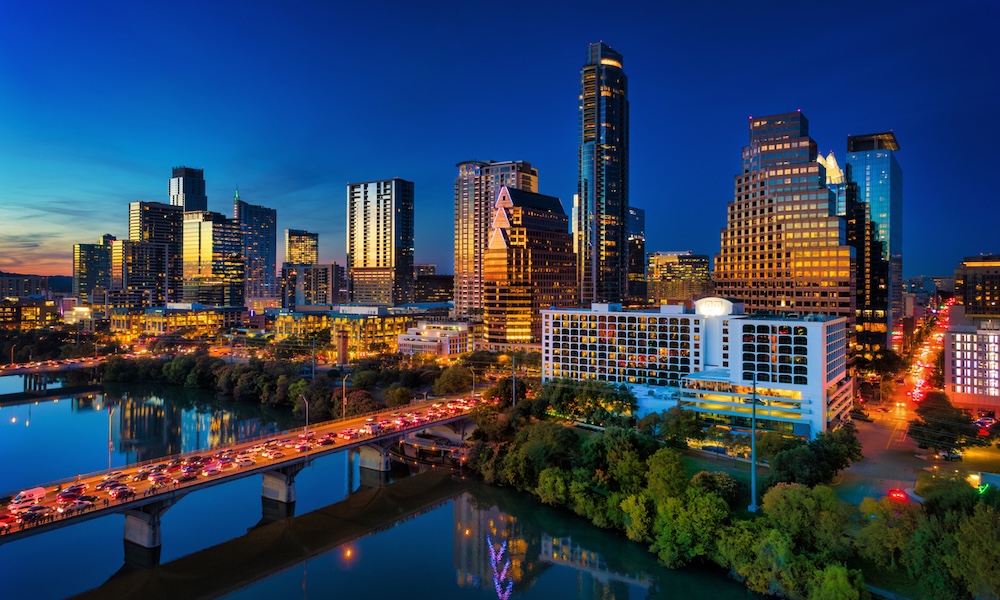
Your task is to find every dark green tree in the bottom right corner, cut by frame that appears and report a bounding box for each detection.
[952,503,1000,598]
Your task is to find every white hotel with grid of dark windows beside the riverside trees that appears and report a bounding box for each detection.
[542,298,854,439]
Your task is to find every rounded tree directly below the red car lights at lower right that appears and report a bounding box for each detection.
[854,496,920,569]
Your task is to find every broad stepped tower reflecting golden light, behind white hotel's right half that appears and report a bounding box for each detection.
[715,112,855,322]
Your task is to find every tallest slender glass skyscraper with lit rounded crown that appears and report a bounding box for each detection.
[573,42,629,305]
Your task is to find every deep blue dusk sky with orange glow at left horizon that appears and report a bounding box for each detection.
[0,0,1000,277]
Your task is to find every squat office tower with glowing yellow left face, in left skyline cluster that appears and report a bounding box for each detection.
[184,211,245,306]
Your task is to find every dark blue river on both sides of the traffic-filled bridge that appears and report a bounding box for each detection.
[0,378,756,600]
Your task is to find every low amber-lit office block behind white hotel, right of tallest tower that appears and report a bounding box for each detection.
[646,250,712,304]
